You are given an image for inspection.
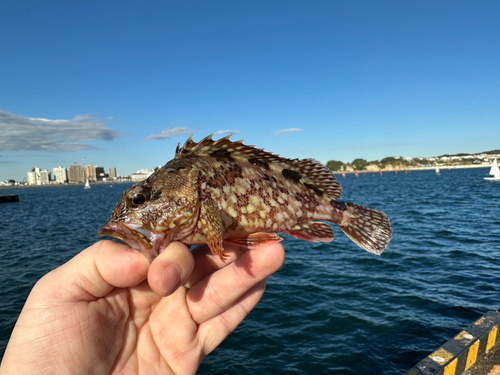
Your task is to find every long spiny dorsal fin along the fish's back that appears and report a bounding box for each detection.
[175,134,342,200]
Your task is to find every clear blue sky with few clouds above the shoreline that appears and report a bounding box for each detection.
[0,0,500,180]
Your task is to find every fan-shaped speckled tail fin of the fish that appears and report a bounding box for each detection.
[332,201,392,255]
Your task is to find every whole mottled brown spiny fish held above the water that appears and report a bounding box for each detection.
[98,134,392,261]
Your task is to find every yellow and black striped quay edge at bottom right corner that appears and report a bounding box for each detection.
[406,311,500,375]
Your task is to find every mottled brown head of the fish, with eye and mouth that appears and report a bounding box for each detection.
[97,166,200,261]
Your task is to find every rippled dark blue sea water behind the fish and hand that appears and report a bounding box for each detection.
[0,168,500,374]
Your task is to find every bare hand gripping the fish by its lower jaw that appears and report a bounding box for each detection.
[0,241,284,375]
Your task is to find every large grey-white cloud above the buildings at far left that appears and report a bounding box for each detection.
[0,110,125,152]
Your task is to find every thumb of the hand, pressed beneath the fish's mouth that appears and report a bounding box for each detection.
[32,241,149,302]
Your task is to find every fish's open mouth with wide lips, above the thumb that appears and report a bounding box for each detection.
[97,221,164,261]
